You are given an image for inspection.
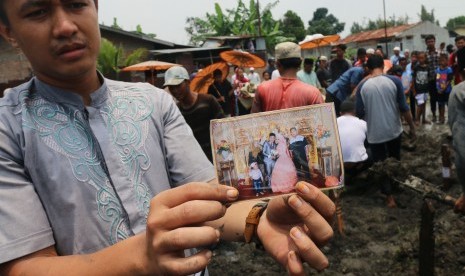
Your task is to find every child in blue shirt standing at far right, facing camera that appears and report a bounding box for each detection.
[436,53,454,124]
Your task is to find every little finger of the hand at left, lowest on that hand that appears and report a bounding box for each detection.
[162,249,213,275]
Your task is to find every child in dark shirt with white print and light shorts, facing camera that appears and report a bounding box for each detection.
[412,52,430,125]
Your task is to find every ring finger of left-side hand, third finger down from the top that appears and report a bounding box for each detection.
[153,226,220,252]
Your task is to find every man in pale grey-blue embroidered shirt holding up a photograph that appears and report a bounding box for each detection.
[0,0,334,276]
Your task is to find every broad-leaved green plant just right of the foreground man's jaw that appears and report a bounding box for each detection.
[97,38,148,79]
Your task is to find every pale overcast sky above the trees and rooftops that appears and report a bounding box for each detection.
[99,0,465,44]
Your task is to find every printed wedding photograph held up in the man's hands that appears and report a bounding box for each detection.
[210,104,344,200]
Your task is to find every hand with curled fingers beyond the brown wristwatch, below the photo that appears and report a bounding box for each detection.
[257,182,335,275]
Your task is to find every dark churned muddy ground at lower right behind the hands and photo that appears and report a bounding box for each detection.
[209,120,465,276]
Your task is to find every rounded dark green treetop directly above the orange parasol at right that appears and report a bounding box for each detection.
[307,8,345,35]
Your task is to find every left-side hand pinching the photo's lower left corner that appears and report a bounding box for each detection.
[144,183,238,275]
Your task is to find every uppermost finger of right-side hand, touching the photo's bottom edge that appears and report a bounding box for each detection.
[295,181,336,221]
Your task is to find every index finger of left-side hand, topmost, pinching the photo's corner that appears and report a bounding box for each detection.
[151,182,239,208]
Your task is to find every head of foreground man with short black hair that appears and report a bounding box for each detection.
[0,0,100,84]
